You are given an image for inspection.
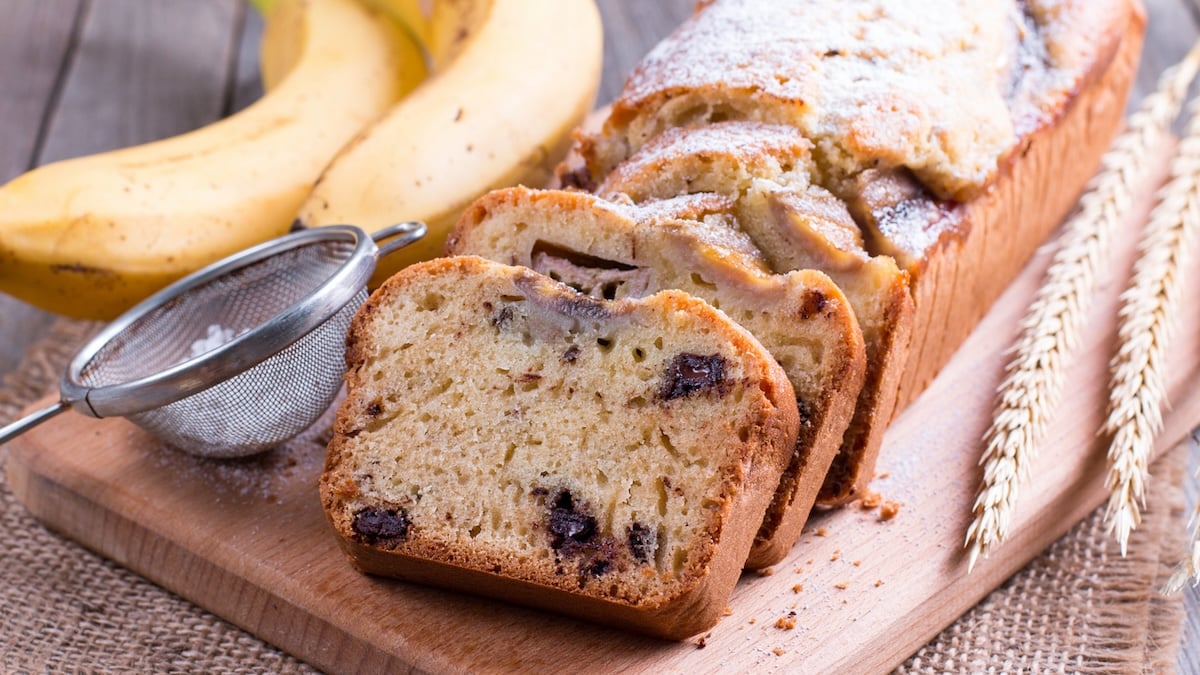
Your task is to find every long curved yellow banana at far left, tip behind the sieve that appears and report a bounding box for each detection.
[0,0,426,318]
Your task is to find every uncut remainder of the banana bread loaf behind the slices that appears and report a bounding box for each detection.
[559,0,1145,480]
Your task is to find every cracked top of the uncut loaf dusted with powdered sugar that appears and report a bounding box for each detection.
[609,0,1124,199]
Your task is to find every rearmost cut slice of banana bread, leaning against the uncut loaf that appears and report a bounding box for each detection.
[596,121,913,506]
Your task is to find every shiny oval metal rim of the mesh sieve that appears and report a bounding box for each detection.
[61,225,379,417]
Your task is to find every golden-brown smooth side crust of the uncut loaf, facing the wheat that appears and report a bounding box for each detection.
[896,2,1145,403]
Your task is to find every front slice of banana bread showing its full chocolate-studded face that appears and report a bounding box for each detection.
[320,256,798,638]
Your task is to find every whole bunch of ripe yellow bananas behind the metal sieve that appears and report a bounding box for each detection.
[0,0,600,318]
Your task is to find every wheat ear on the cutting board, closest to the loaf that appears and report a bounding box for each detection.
[964,42,1200,571]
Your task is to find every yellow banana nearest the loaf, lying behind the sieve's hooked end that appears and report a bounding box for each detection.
[299,0,602,280]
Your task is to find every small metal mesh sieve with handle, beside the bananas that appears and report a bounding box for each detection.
[0,222,426,458]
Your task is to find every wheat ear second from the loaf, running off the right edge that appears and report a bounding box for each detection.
[1104,93,1200,555]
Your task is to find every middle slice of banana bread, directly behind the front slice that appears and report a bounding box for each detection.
[446,187,866,568]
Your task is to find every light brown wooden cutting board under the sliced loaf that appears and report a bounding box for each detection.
[7,149,1200,673]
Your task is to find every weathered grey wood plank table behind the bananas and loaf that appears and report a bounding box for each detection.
[0,0,1200,673]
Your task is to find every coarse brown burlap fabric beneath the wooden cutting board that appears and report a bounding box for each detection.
[0,319,1186,673]
